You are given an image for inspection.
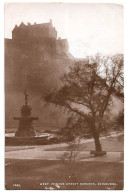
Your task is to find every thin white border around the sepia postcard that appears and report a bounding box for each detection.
[0,0,126,195]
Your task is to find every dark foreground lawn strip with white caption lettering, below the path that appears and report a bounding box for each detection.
[5,159,123,190]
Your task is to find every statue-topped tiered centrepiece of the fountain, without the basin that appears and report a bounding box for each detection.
[14,90,38,137]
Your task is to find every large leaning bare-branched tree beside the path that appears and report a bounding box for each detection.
[46,54,123,151]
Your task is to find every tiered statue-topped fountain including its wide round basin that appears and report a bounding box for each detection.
[5,90,50,146]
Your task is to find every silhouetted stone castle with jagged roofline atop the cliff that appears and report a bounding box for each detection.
[12,20,68,55]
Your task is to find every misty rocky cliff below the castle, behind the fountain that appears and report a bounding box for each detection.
[5,39,74,127]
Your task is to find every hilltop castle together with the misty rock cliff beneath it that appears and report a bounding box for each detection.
[5,20,75,127]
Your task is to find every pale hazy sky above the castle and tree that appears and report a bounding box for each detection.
[5,3,123,58]
